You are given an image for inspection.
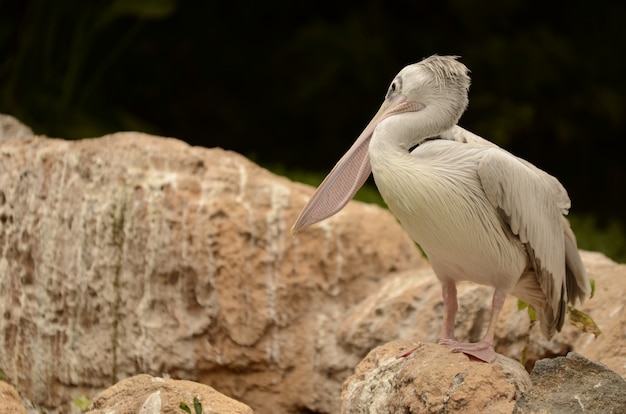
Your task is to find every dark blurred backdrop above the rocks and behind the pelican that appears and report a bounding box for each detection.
[0,0,626,258]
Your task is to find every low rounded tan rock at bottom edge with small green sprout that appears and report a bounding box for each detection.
[86,374,253,414]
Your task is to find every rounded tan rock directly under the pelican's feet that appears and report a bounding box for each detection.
[341,341,531,414]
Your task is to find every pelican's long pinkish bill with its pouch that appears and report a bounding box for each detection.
[291,95,424,234]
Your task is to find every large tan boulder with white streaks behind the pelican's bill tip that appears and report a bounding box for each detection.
[0,133,425,413]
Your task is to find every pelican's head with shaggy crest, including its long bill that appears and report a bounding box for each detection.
[292,55,470,233]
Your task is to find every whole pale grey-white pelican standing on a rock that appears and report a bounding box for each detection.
[292,55,590,362]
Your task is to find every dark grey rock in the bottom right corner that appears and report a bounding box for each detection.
[514,352,626,414]
